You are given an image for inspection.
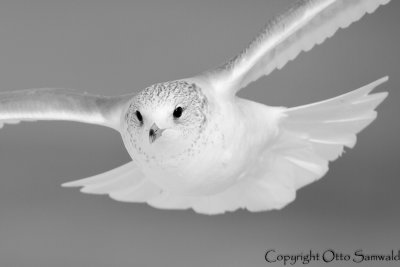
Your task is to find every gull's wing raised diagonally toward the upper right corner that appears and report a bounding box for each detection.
[200,0,390,95]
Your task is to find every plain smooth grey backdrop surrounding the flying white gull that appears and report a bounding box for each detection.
[0,0,400,267]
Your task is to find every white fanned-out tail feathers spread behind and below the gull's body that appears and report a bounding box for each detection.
[64,77,388,214]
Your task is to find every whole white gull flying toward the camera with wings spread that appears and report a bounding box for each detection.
[0,0,390,214]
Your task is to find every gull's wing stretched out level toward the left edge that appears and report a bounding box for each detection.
[0,88,130,131]
